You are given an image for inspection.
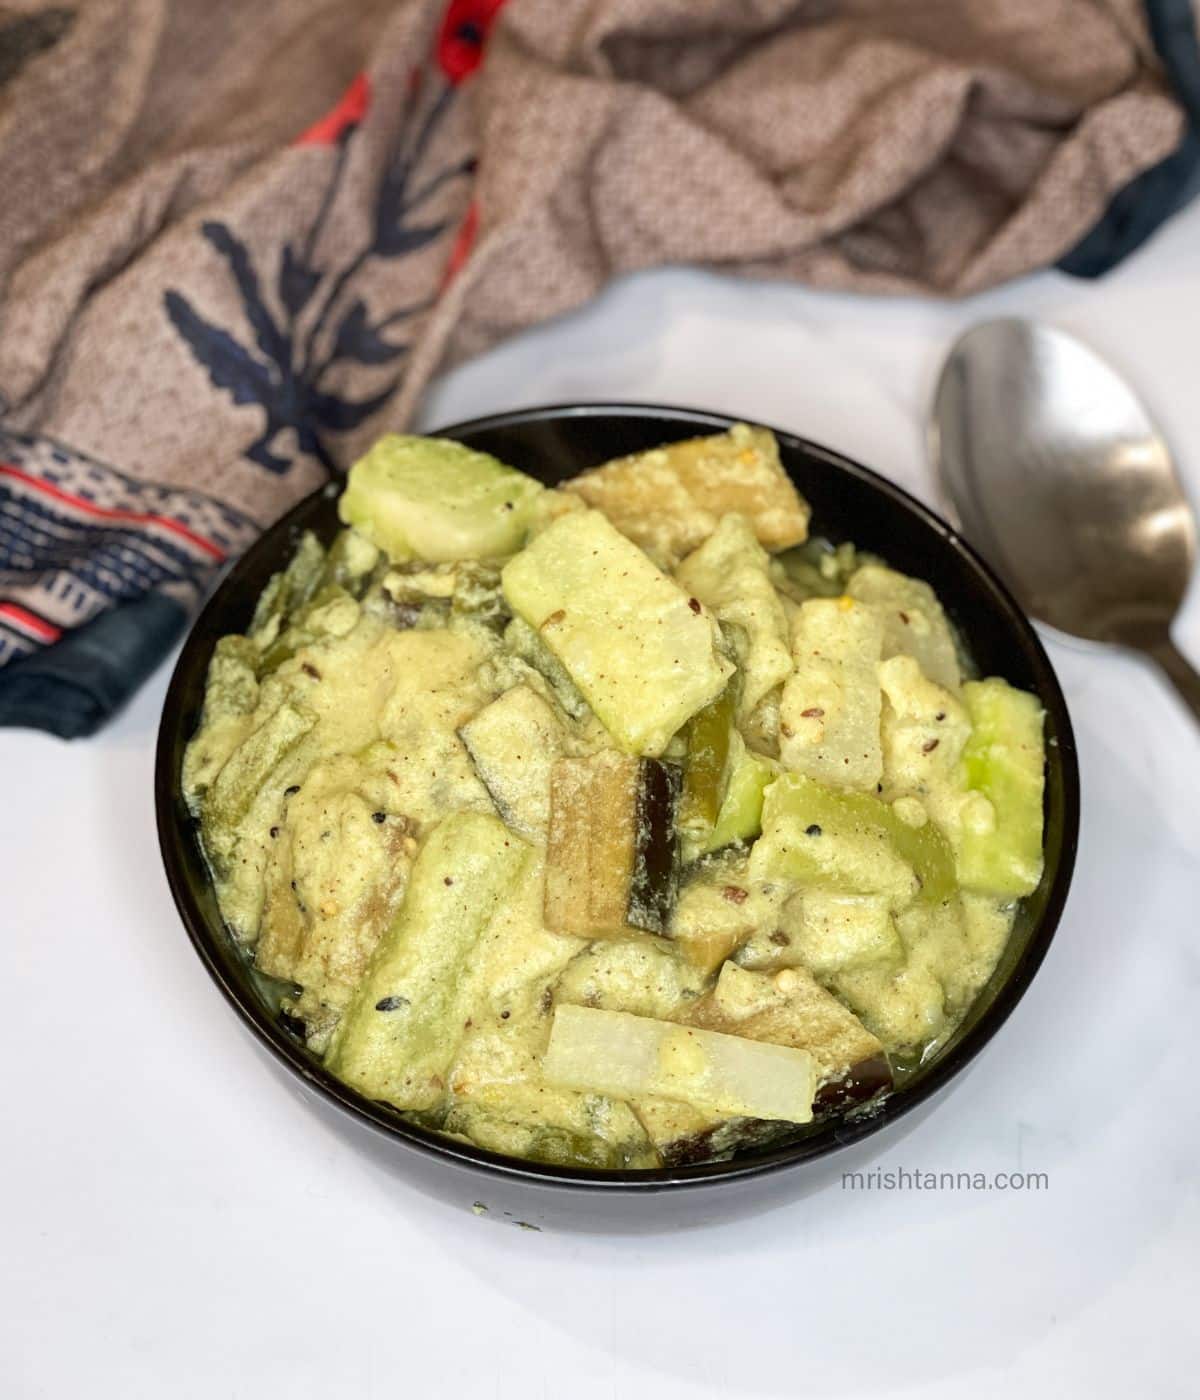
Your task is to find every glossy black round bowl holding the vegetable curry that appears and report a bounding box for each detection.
[155,405,1080,1224]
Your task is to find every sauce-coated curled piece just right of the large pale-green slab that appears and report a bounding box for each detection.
[675,515,793,714]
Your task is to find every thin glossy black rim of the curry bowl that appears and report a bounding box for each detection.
[154,400,1080,1196]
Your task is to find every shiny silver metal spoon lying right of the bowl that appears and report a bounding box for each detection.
[930,321,1200,720]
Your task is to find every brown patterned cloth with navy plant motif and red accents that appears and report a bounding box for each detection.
[0,0,1185,732]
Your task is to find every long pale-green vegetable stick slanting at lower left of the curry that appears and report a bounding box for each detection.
[326,812,529,1109]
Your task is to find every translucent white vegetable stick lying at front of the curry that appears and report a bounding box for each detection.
[543,1007,816,1123]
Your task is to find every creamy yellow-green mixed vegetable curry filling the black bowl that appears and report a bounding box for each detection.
[183,424,1045,1168]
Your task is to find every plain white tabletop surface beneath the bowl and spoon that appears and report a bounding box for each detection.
[7,206,1200,1400]
